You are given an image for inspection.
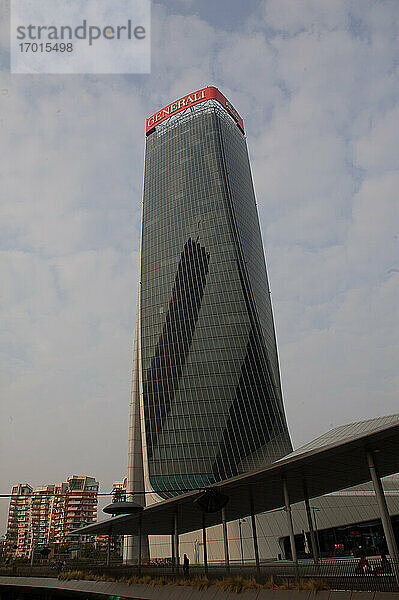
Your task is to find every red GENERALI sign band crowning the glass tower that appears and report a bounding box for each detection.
[146,86,244,134]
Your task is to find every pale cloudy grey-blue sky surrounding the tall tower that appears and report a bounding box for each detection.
[0,0,399,533]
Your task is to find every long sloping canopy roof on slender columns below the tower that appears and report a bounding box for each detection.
[73,414,399,535]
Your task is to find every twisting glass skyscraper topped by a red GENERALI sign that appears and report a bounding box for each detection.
[128,88,292,516]
